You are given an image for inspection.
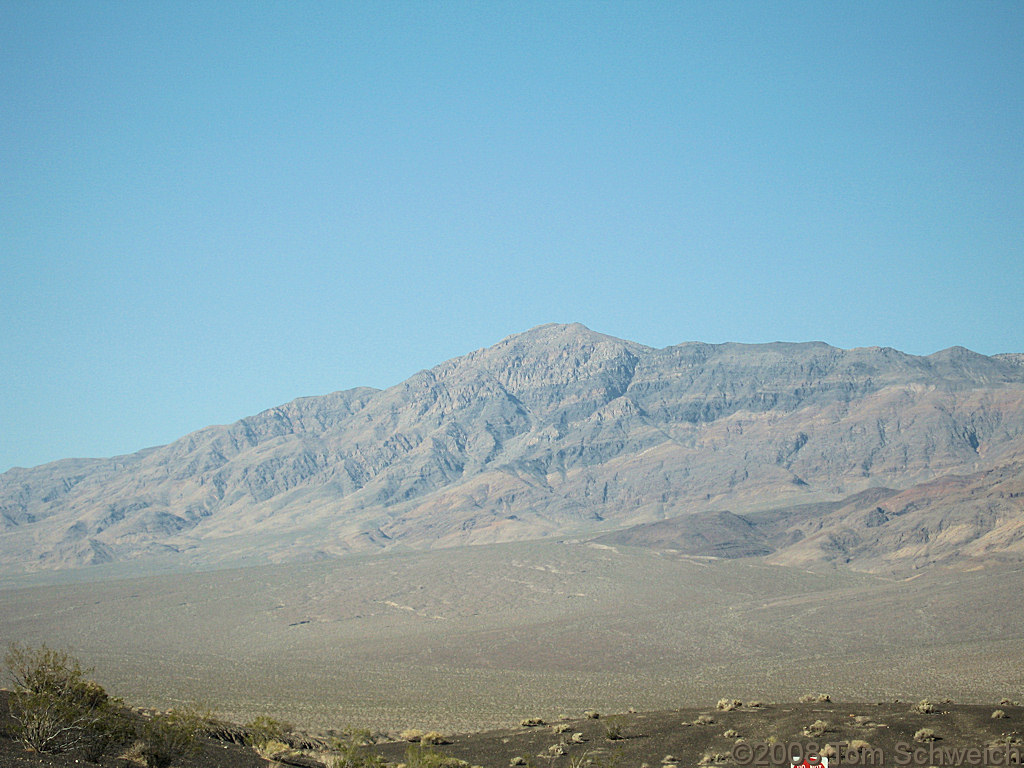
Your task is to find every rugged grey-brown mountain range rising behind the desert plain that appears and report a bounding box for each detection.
[0,324,1024,570]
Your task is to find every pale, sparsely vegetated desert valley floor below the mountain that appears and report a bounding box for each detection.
[0,541,1024,731]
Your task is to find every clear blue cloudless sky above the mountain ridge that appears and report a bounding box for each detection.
[0,0,1024,471]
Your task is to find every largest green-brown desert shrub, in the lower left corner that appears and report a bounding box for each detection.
[4,644,124,759]
